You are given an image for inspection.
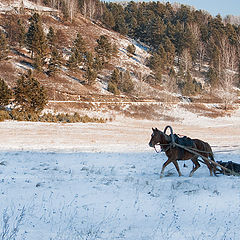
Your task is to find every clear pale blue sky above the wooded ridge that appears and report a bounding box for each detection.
[163,0,240,17]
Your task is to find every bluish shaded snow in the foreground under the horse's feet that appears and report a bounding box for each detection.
[0,151,240,240]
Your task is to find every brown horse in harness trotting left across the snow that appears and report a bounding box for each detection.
[149,128,215,178]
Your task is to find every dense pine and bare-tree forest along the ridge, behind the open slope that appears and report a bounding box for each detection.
[36,0,240,99]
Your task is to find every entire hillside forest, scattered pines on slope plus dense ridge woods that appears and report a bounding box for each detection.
[0,0,240,120]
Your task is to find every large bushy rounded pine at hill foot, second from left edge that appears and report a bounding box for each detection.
[14,71,47,113]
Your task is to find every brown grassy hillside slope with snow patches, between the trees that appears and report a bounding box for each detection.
[0,0,239,118]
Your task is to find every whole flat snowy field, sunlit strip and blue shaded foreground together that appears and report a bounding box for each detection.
[0,111,240,240]
